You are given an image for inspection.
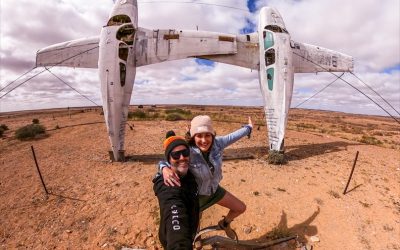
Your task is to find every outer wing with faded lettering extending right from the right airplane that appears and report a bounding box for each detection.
[291,41,354,73]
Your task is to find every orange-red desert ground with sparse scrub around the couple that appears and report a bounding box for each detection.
[0,106,400,250]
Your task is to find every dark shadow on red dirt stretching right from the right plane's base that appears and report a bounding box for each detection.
[285,141,362,161]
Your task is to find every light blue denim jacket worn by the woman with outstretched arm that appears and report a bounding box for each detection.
[158,125,252,195]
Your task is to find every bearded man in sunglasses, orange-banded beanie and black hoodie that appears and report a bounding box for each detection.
[153,131,199,250]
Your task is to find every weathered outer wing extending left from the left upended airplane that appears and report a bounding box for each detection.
[36,37,99,68]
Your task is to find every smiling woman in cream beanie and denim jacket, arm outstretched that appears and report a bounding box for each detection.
[159,115,253,239]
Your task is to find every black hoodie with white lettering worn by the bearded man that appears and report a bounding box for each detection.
[153,171,199,250]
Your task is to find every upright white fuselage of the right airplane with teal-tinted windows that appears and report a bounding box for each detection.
[258,7,294,153]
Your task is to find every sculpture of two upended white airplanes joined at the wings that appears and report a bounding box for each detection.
[36,0,353,161]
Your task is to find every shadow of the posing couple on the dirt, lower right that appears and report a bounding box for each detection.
[238,207,320,249]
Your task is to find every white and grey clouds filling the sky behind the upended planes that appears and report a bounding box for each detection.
[0,0,400,114]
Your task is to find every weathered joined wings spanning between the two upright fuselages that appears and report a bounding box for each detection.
[135,28,259,69]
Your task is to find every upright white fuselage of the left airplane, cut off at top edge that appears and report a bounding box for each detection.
[98,0,137,161]
